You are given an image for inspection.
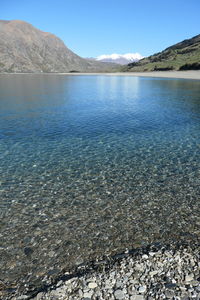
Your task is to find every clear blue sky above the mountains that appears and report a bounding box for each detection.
[0,0,200,57]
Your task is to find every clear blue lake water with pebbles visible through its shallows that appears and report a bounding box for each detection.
[0,75,200,291]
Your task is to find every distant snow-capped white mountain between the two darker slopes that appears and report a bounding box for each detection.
[95,53,144,65]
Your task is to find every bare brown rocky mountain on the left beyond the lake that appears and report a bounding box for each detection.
[0,20,116,73]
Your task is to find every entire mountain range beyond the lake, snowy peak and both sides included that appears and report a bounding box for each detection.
[0,20,200,73]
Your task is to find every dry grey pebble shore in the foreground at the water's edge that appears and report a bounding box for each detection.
[12,243,200,300]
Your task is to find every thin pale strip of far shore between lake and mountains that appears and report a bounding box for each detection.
[0,70,200,80]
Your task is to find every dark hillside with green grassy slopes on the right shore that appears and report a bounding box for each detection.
[121,34,200,72]
